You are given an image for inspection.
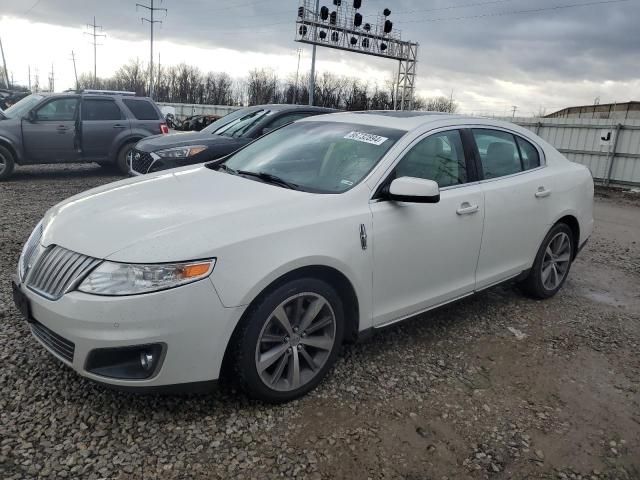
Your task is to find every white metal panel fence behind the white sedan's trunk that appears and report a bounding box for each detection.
[503,118,640,185]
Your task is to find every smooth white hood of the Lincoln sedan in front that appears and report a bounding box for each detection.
[42,166,316,263]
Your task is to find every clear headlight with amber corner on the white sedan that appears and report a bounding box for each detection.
[78,259,216,296]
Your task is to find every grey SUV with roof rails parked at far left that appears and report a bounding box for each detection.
[0,90,169,180]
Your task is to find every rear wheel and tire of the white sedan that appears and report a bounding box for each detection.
[520,223,575,300]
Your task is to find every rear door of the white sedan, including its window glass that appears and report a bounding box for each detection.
[471,128,552,289]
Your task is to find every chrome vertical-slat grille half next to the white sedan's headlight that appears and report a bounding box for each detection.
[26,246,100,300]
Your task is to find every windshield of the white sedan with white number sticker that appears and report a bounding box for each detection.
[216,121,406,193]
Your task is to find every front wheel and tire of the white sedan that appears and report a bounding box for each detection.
[232,278,344,403]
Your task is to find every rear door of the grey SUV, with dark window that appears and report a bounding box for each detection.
[81,97,131,161]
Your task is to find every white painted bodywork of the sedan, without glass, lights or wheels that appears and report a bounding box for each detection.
[15,113,593,386]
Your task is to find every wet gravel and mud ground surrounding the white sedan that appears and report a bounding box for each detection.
[0,166,640,480]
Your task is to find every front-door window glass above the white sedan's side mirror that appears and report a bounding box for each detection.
[395,130,467,188]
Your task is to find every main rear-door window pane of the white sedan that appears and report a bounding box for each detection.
[473,129,523,179]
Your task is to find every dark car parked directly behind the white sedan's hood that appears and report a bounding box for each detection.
[129,105,336,175]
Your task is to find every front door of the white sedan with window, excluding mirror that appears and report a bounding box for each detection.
[371,130,484,326]
